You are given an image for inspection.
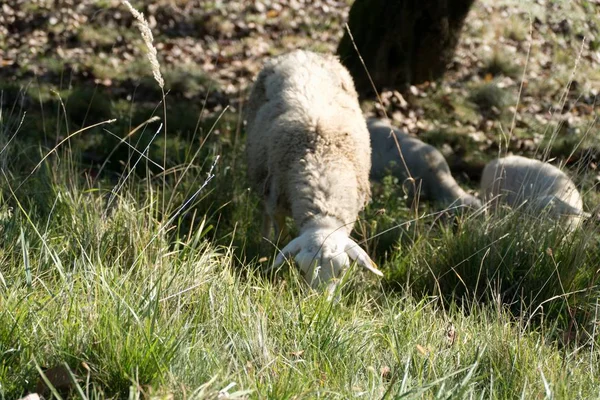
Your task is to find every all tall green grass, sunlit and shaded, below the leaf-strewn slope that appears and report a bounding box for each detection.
[0,105,600,399]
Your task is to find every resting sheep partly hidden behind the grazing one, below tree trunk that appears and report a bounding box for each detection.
[367,118,481,210]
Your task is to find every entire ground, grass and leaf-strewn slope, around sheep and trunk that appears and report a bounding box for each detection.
[0,0,600,400]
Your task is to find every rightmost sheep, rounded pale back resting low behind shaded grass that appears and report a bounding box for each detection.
[480,156,589,228]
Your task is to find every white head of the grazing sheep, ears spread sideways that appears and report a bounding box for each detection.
[273,227,383,291]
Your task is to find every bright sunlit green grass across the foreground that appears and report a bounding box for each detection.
[0,164,598,398]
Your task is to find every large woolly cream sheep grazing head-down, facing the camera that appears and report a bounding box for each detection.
[246,51,382,291]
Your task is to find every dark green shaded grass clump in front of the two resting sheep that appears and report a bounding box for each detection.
[386,206,599,334]
